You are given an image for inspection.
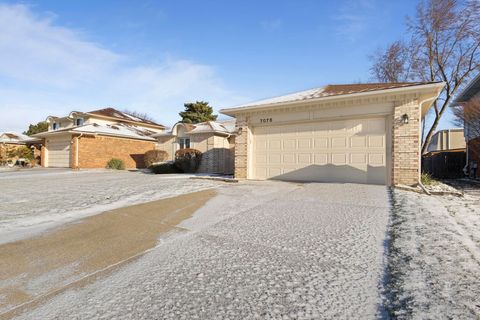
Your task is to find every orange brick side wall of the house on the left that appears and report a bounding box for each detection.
[77,136,155,168]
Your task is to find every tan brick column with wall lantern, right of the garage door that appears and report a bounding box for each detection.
[392,100,421,185]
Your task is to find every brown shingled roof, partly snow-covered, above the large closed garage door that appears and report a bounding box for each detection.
[220,82,442,114]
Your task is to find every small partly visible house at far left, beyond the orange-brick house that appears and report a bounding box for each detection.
[0,132,41,164]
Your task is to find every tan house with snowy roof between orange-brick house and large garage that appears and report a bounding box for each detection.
[154,120,235,174]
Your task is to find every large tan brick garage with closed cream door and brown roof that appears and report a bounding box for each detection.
[220,82,444,185]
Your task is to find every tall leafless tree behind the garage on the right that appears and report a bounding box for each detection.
[372,0,480,153]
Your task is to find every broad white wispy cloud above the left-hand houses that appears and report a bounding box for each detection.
[0,4,243,131]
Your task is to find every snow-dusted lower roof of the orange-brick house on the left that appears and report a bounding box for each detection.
[35,123,156,141]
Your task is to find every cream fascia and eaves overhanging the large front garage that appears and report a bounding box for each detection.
[220,82,445,117]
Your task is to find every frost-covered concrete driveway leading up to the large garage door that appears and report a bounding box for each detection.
[15,182,390,319]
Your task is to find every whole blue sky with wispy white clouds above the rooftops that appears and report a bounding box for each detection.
[0,0,458,131]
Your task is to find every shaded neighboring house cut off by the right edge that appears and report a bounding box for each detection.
[451,73,480,178]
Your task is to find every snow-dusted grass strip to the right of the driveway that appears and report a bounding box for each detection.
[389,190,480,319]
